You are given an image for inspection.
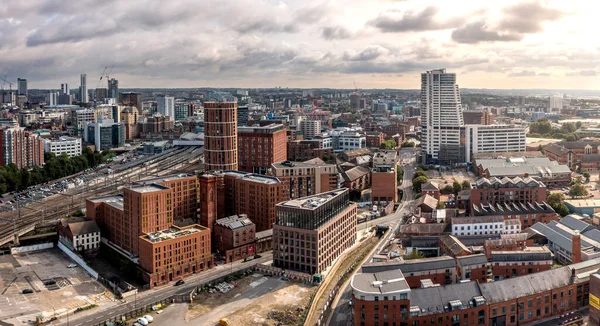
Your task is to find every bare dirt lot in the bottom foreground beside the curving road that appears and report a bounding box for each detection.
[186,274,316,326]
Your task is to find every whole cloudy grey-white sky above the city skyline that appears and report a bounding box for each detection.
[0,0,600,89]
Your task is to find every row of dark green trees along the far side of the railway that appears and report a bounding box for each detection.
[0,147,115,194]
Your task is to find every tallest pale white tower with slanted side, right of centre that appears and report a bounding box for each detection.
[421,69,464,164]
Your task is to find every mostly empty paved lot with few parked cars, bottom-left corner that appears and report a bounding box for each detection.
[0,248,111,325]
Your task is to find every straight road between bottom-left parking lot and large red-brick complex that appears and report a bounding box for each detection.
[57,253,273,326]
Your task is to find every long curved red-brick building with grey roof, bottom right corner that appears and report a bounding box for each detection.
[350,259,600,326]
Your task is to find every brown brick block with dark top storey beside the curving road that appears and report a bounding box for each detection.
[273,189,357,274]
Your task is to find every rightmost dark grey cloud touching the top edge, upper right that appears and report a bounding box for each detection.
[499,1,565,33]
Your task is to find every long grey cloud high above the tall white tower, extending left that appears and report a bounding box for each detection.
[369,6,460,33]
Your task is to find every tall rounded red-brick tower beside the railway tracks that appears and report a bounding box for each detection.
[204,102,238,171]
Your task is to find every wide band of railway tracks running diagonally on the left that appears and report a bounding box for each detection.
[0,148,202,246]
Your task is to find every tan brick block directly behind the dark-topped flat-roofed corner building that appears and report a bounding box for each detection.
[271,159,340,200]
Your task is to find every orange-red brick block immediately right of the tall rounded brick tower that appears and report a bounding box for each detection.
[238,124,287,174]
